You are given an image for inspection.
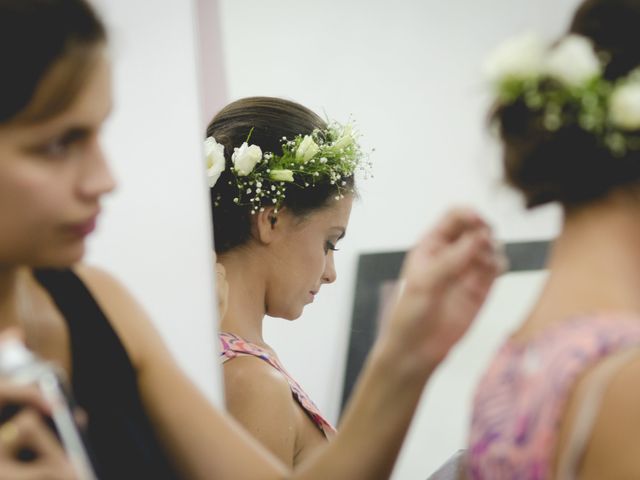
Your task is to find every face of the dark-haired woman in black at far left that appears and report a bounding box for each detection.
[0,54,115,266]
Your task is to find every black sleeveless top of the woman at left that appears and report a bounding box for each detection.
[33,269,180,480]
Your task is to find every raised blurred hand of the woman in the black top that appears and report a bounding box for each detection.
[388,209,506,368]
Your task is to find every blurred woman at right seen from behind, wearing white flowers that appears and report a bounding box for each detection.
[468,0,640,480]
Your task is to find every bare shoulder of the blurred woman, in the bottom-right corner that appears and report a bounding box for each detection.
[560,347,640,479]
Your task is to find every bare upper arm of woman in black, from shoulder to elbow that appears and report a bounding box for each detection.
[78,267,287,480]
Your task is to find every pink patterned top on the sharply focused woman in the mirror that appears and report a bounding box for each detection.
[219,332,336,438]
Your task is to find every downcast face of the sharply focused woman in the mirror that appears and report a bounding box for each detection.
[266,195,353,320]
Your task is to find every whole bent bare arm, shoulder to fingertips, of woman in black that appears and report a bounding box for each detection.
[79,211,498,480]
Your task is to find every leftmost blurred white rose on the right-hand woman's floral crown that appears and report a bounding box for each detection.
[484,32,545,84]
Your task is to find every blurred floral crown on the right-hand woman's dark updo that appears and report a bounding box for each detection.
[485,33,640,157]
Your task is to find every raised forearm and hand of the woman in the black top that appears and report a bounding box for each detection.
[296,211,501,480]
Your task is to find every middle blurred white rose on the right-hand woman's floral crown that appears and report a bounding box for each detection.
[544,35,601,87]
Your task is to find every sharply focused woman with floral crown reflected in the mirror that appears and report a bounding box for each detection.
[206,97,500,466]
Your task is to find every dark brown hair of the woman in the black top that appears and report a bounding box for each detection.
[0,0,107,125]
